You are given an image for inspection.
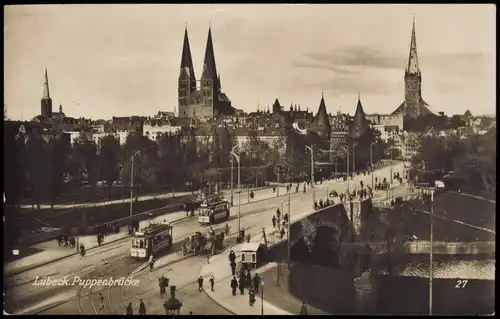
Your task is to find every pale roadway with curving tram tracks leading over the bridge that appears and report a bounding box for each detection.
[4,165,402,314]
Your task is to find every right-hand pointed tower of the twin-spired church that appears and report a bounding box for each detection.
[201,26,219,116]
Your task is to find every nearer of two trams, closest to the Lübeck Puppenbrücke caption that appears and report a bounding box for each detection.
[130,224,172,259]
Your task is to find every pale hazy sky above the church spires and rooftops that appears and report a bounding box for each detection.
[4,4,496,120]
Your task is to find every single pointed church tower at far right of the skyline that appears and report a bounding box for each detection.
[404,18,422,117]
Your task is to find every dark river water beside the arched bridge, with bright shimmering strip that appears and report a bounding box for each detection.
[289,246,495,315]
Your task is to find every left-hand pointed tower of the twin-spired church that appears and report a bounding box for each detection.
[177,25,196,114]
